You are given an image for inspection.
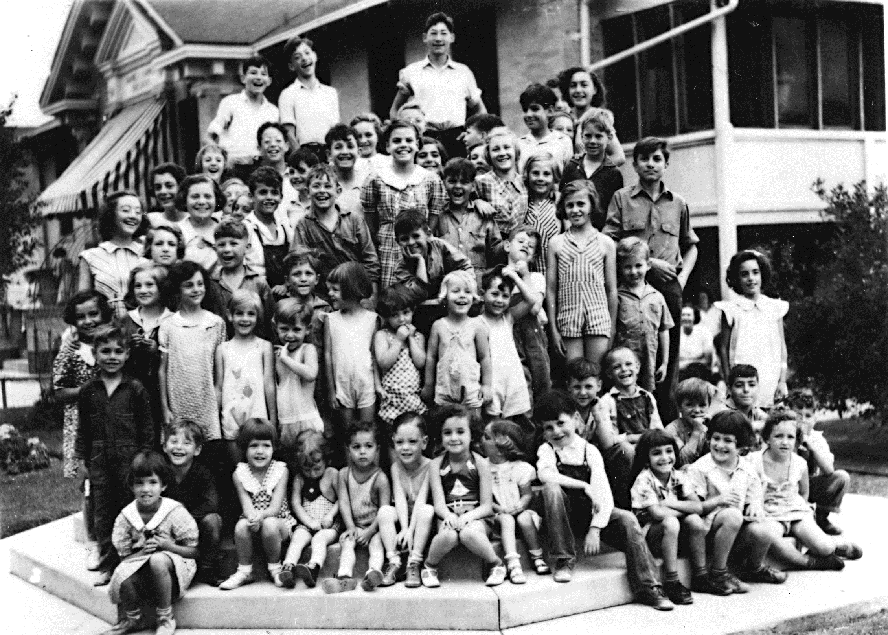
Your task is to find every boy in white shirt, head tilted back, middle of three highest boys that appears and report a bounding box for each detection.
[278,37,339,160]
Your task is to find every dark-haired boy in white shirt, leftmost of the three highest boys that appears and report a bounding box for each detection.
[207,56,280,167]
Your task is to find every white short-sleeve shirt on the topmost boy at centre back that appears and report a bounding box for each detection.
[398,57,481,127]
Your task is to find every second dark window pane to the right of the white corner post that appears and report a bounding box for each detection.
[774,17,816,128]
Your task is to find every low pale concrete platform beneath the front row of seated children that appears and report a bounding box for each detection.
[8,496,888,635]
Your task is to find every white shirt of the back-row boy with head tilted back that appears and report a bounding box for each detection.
[278,79,339,145]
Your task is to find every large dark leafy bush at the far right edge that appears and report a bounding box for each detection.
[787,181,888,416]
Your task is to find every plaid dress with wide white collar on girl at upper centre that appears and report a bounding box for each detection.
[361,166,447,289]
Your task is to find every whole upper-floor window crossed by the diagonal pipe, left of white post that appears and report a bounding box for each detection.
[603,3,713,141]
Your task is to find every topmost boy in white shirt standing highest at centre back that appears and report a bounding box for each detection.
[389,13,487,158]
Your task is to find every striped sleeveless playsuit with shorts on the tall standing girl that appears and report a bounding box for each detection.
[556,231,611,337]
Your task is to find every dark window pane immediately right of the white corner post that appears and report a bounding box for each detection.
[728,7,774,128]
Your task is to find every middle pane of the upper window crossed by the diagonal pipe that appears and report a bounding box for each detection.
[635,6,676,136]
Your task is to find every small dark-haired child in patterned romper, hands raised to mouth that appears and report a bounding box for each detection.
[373,284,426,425]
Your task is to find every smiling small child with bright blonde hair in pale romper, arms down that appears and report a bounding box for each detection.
[422,271,493,416]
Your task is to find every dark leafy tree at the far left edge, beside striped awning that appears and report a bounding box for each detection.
[0,97,39,275]
